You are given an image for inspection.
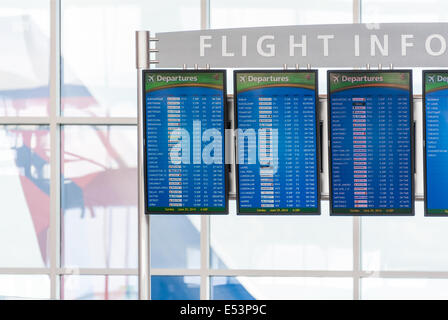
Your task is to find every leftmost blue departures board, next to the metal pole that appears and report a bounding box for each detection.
[143,70,228,214]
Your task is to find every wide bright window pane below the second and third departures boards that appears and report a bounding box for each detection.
[210,201,353,270]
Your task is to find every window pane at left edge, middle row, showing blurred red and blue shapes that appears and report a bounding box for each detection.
[0,125,50,268]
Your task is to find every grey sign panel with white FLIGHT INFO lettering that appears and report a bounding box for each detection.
[156,23,448,68]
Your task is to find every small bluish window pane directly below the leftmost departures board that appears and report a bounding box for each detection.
[150,215,201,269]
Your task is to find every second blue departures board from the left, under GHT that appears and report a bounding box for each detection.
[234,70,320,215]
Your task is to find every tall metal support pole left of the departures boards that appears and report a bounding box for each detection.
[135,31,151,300]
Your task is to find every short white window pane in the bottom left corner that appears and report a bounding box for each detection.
[0,274,50,300]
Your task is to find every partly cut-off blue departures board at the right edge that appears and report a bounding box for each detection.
[423,70,448,216]
